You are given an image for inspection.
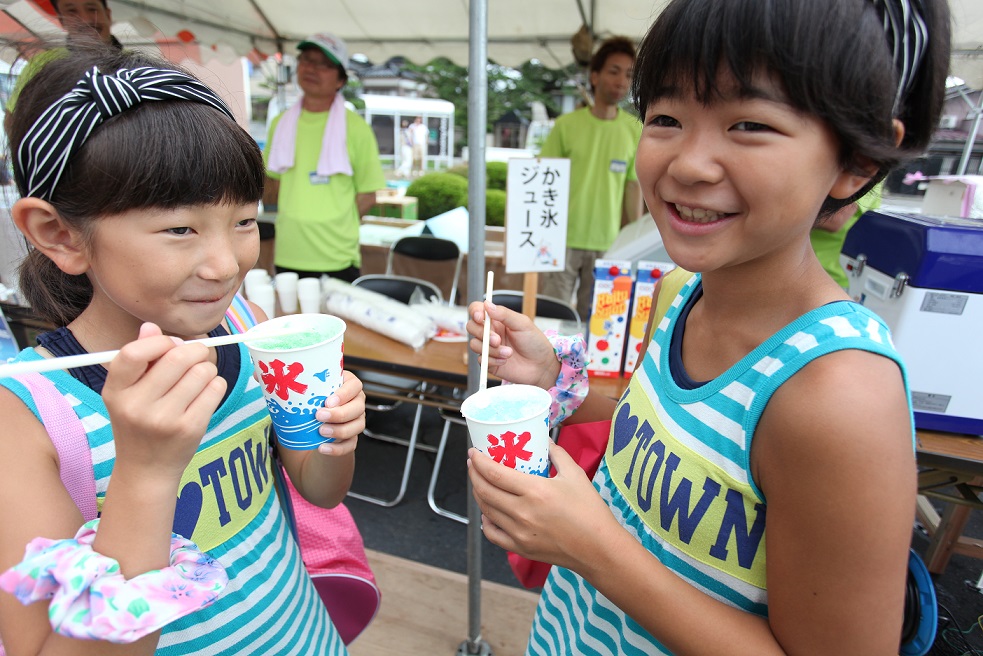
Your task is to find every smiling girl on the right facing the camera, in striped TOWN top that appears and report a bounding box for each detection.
[468,0,950,656]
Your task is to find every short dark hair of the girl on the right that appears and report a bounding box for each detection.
[632,0,950,208]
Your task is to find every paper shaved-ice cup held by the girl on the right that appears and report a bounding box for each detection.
[461,385,553,476]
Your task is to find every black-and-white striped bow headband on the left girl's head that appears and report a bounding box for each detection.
[17,66,235,201]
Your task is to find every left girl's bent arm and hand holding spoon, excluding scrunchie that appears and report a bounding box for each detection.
[0,324,224,656]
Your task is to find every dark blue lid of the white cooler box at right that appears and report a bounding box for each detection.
[843,210,983,294]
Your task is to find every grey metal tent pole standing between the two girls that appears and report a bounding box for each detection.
[457,0,492,656]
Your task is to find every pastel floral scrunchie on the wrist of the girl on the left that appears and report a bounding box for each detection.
[0,519,229,643]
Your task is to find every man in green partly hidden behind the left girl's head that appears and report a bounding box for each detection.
[4,0,123,132]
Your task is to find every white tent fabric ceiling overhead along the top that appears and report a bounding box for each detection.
[0,0,983,66]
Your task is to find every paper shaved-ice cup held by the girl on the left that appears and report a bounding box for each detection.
[246,314,345,450]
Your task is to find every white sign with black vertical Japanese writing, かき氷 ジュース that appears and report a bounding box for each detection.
[505,158,570,273]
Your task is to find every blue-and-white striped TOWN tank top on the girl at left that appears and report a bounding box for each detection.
[0,344,347,656]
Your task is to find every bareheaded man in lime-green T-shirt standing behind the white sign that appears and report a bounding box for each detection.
[539,37,642,319]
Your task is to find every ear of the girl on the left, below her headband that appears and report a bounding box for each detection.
[10,198,89,276]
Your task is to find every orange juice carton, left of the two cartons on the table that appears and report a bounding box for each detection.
[587,260,633,378]
